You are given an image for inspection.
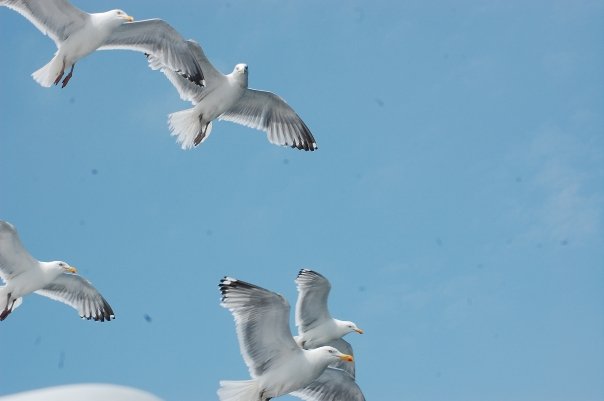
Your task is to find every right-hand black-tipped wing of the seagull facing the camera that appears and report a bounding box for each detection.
[219,89,317,151]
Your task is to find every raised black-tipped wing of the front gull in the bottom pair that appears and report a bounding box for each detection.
[219,277,302,377]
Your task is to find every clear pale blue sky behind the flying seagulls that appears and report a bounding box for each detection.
[0,0,604,401]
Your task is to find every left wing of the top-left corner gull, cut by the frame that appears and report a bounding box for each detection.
[0,0,90,47]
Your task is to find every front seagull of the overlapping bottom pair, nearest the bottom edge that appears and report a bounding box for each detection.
[218,277,365,401]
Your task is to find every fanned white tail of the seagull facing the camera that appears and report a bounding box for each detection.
[168,107,212,149]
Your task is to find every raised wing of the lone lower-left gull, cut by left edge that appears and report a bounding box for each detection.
[0,220,39,281]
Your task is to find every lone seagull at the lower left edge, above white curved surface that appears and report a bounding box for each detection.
[0,220,115,322]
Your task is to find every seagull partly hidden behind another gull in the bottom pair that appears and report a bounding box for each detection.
[294,269,363,377]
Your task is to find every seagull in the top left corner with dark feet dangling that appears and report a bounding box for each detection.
[0,0,203,88]
